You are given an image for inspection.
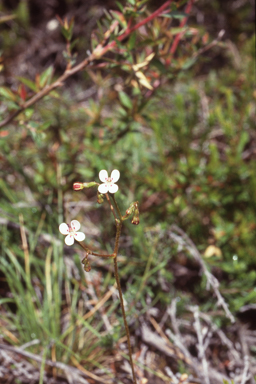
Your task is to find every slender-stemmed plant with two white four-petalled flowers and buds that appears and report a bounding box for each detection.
[59,169,140,384]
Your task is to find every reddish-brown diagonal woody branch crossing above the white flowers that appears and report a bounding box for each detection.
[0,0,173,128]
